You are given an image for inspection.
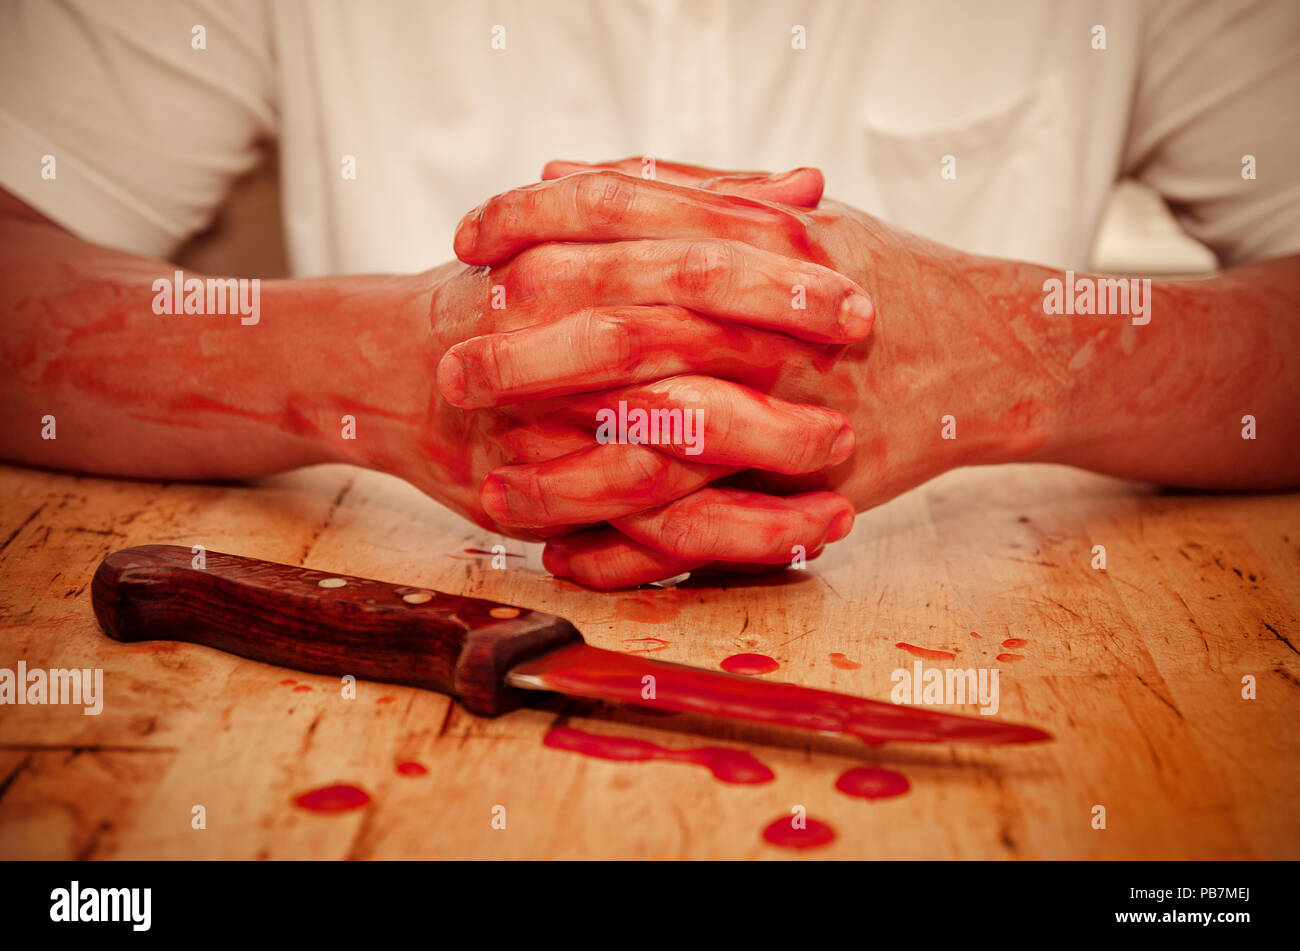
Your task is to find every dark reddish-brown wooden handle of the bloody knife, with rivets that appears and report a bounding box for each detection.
[100,544,582,716]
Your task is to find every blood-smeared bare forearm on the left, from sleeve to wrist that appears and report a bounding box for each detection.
[0,205,428,478]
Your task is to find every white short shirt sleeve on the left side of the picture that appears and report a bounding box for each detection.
[0,0,276,257]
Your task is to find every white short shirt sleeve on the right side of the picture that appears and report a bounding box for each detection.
[1123,0,1300,265]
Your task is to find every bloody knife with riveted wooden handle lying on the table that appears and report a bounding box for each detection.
[91,544,1050,744]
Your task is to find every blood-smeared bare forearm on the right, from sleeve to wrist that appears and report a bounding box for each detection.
[969,256,1300,488]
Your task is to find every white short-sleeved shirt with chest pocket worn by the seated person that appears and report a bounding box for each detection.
[0,0,1300,275]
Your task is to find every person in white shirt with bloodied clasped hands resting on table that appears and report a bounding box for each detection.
[0,0,1300,587]
